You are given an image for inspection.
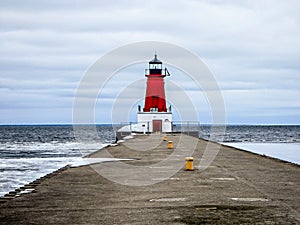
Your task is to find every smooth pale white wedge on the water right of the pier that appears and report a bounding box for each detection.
[222,142,300,165]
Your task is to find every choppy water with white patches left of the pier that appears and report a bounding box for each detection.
[0,125,113,196]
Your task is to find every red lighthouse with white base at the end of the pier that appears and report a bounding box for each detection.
[137,54,172,133]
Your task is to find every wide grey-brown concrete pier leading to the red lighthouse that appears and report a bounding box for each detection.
[0,135,300,225]
